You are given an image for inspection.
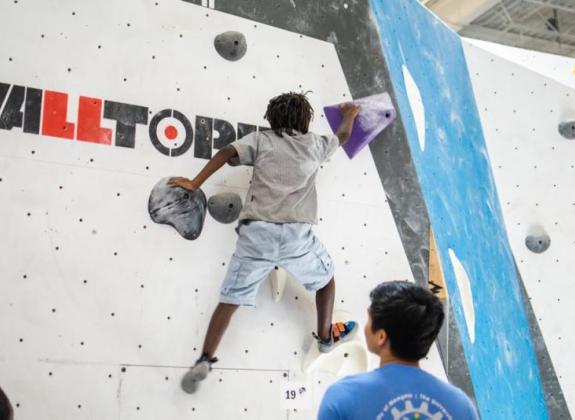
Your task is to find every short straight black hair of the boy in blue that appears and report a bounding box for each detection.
[369,281,445,361]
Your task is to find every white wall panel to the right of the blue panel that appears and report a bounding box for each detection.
[464,43,575,412]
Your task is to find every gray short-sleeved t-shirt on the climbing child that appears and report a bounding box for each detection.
[231,130,339,224]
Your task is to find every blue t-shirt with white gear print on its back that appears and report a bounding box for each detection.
[318,364,478,420]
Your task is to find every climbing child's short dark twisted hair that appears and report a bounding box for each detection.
[264,92,313,136]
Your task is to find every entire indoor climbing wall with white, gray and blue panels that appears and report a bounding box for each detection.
[0,0,575,420]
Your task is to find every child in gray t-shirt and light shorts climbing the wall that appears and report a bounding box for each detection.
[169,92,359,393]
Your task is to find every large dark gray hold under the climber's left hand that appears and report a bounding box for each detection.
[148,178,207,240]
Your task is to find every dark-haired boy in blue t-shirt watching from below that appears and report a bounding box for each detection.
[318,281,478,420]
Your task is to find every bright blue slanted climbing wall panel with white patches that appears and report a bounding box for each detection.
[371,0,548,419]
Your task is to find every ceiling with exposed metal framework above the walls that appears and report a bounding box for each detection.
[421,0,575,57]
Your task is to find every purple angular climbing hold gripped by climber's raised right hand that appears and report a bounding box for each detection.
[323,93,397,159]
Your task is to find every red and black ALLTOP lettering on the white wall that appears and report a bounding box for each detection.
[0,83,267,159]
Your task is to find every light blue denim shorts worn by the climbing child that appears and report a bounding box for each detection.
[220,220,334,306]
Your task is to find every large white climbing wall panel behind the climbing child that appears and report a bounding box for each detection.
[0,0,442,420]
